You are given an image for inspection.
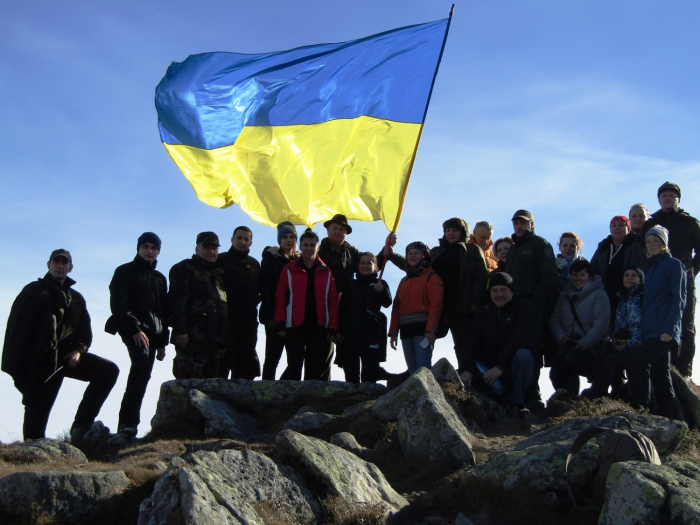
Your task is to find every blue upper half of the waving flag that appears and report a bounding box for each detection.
[156,19,448,149]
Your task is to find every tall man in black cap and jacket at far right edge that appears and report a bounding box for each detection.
[644,182,700,377]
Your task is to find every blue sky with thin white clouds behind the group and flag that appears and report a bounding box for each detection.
[0,0,700,442]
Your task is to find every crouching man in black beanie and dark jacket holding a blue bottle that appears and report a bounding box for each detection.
[458,273,539,418]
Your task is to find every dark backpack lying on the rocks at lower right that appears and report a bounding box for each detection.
[564,418,661,509]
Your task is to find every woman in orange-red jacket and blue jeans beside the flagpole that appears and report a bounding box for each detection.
[389,242,443,373]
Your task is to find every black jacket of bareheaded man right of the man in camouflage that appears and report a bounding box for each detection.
[216,246,260,323]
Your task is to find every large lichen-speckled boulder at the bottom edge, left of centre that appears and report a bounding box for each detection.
[139,450,319,525]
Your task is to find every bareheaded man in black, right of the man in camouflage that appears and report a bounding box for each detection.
[216,226,260,379]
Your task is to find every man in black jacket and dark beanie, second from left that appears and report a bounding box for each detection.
[105,232,169,438]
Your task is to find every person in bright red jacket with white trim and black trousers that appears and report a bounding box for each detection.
[275,228,338,381]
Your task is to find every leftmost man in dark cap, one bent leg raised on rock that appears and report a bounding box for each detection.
[2,249,119,444]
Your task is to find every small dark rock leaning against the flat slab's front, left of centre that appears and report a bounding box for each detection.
[189,389,265,443]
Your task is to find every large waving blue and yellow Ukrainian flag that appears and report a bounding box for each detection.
[156,19,449,227]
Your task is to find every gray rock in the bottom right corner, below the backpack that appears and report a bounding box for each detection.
[598,461,700,525]
